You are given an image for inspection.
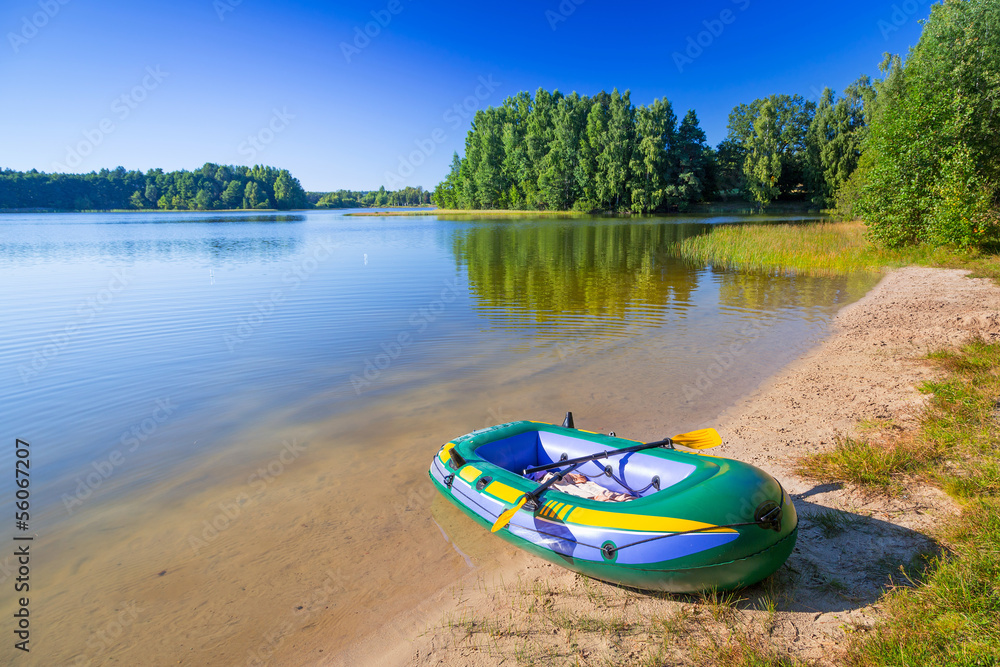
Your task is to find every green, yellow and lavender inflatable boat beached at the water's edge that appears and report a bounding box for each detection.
[429,418,798,593]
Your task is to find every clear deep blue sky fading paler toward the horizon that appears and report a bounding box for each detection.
[0,0,930,191]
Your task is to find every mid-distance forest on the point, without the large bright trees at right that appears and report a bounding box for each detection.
[434,83,875,213]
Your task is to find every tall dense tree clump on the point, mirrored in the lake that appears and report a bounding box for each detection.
[434,89,714,213]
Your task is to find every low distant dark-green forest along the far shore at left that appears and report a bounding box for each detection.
[0,163,430,211]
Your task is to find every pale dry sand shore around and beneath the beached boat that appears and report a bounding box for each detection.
[332,268,1000,665]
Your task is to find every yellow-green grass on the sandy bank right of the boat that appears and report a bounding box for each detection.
[799,340,1000,667]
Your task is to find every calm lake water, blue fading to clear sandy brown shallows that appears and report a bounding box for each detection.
[0,212,875,664]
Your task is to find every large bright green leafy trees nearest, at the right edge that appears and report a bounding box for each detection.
[857,0,1000,247]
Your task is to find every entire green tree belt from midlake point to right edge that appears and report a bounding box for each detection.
[433,0,1000,247]
